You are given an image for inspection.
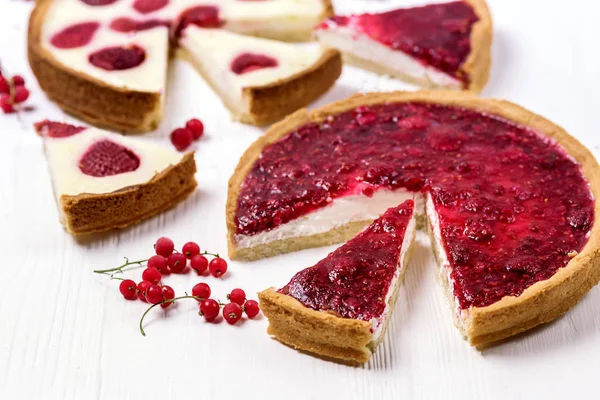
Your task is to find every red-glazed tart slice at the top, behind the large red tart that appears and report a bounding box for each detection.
[315,0,492,92]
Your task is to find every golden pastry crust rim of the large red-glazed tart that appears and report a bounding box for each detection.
[226,91,600,356]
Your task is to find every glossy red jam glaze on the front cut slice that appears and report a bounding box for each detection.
[279,200,414,321]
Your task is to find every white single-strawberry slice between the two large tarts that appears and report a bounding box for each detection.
[180,25,342,125]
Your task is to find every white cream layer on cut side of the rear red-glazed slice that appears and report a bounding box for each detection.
[315,26,462,89]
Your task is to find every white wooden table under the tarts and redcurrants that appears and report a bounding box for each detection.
[0,0,600,400]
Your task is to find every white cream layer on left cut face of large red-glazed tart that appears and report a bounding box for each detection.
[235,189,424,249]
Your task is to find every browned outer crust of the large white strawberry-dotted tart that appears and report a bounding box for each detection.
[27,0,162,133]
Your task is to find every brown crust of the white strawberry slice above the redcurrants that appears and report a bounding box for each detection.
[59,153,197,235]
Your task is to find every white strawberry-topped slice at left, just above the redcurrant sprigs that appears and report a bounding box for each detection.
[35,121,196,235]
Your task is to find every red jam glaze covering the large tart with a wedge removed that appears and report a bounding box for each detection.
[235,103,594,309]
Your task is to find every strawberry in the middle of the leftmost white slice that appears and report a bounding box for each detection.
[79,139,140,177]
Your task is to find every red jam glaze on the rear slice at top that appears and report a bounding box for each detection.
[320,1,478,82]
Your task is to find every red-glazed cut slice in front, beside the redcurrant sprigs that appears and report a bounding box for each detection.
[258,200,416,363]
